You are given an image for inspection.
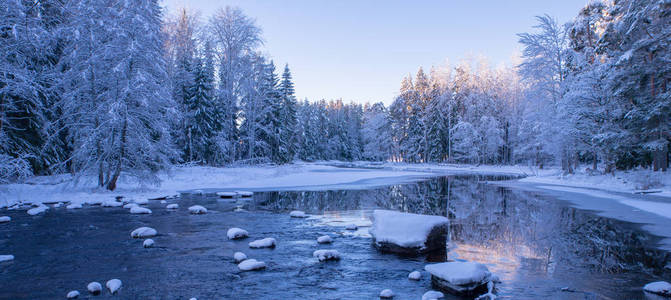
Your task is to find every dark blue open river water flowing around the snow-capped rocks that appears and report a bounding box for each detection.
[0,176,671,300]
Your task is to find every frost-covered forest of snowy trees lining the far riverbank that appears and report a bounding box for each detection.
[0,0,671,189]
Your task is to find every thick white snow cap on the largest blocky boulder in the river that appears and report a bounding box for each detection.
[370,210,448,248]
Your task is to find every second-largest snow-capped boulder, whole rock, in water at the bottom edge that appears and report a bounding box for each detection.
[424,261,492,296]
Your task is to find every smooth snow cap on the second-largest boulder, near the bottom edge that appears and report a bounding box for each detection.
[424,261,492,285]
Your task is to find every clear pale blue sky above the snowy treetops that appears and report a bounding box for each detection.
[163,0,587,104]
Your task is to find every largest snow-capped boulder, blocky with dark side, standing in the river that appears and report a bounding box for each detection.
[370,210,448,255]
